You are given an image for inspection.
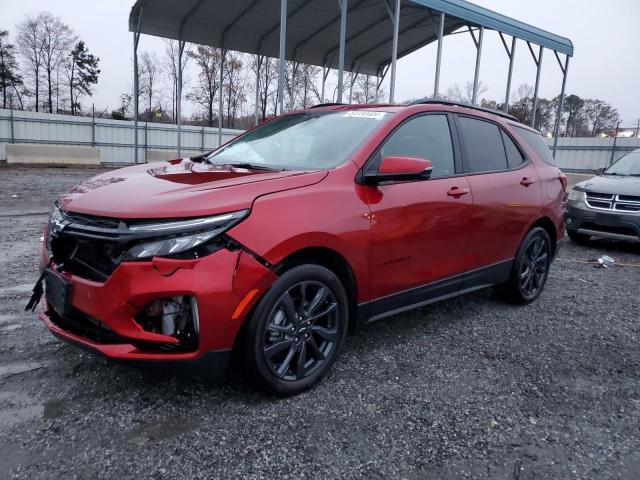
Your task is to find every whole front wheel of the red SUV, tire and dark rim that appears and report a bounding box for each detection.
[245,265,349,395]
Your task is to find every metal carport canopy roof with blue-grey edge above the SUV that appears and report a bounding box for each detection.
[129,0,573,75]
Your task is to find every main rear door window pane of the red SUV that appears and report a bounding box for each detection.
[458,117,507,173]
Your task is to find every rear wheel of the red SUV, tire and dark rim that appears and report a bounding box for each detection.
[502,227,553,304]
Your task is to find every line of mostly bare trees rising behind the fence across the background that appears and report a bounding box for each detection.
[0,12,620,136]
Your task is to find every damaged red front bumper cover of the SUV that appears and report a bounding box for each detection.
[40,249,276,363]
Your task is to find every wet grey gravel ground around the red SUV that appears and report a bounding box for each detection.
[0,168,640,479]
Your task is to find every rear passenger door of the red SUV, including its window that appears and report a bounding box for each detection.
[457,115,540,276]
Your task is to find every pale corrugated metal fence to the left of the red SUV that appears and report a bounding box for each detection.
[0,109,242,165]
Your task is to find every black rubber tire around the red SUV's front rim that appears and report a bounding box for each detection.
[245,264,349,395]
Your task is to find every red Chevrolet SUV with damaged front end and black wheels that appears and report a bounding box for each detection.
[31,101,566,394]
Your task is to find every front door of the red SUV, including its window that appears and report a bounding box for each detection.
[365,113,471,316]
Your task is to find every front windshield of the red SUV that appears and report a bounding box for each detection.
[206,110,389,170]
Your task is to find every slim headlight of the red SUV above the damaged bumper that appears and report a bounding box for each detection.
[124,210,249,261]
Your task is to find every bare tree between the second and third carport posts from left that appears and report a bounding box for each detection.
[187,45,222,127]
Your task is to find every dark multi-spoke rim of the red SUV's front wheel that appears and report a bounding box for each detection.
[262,281,340,380]
